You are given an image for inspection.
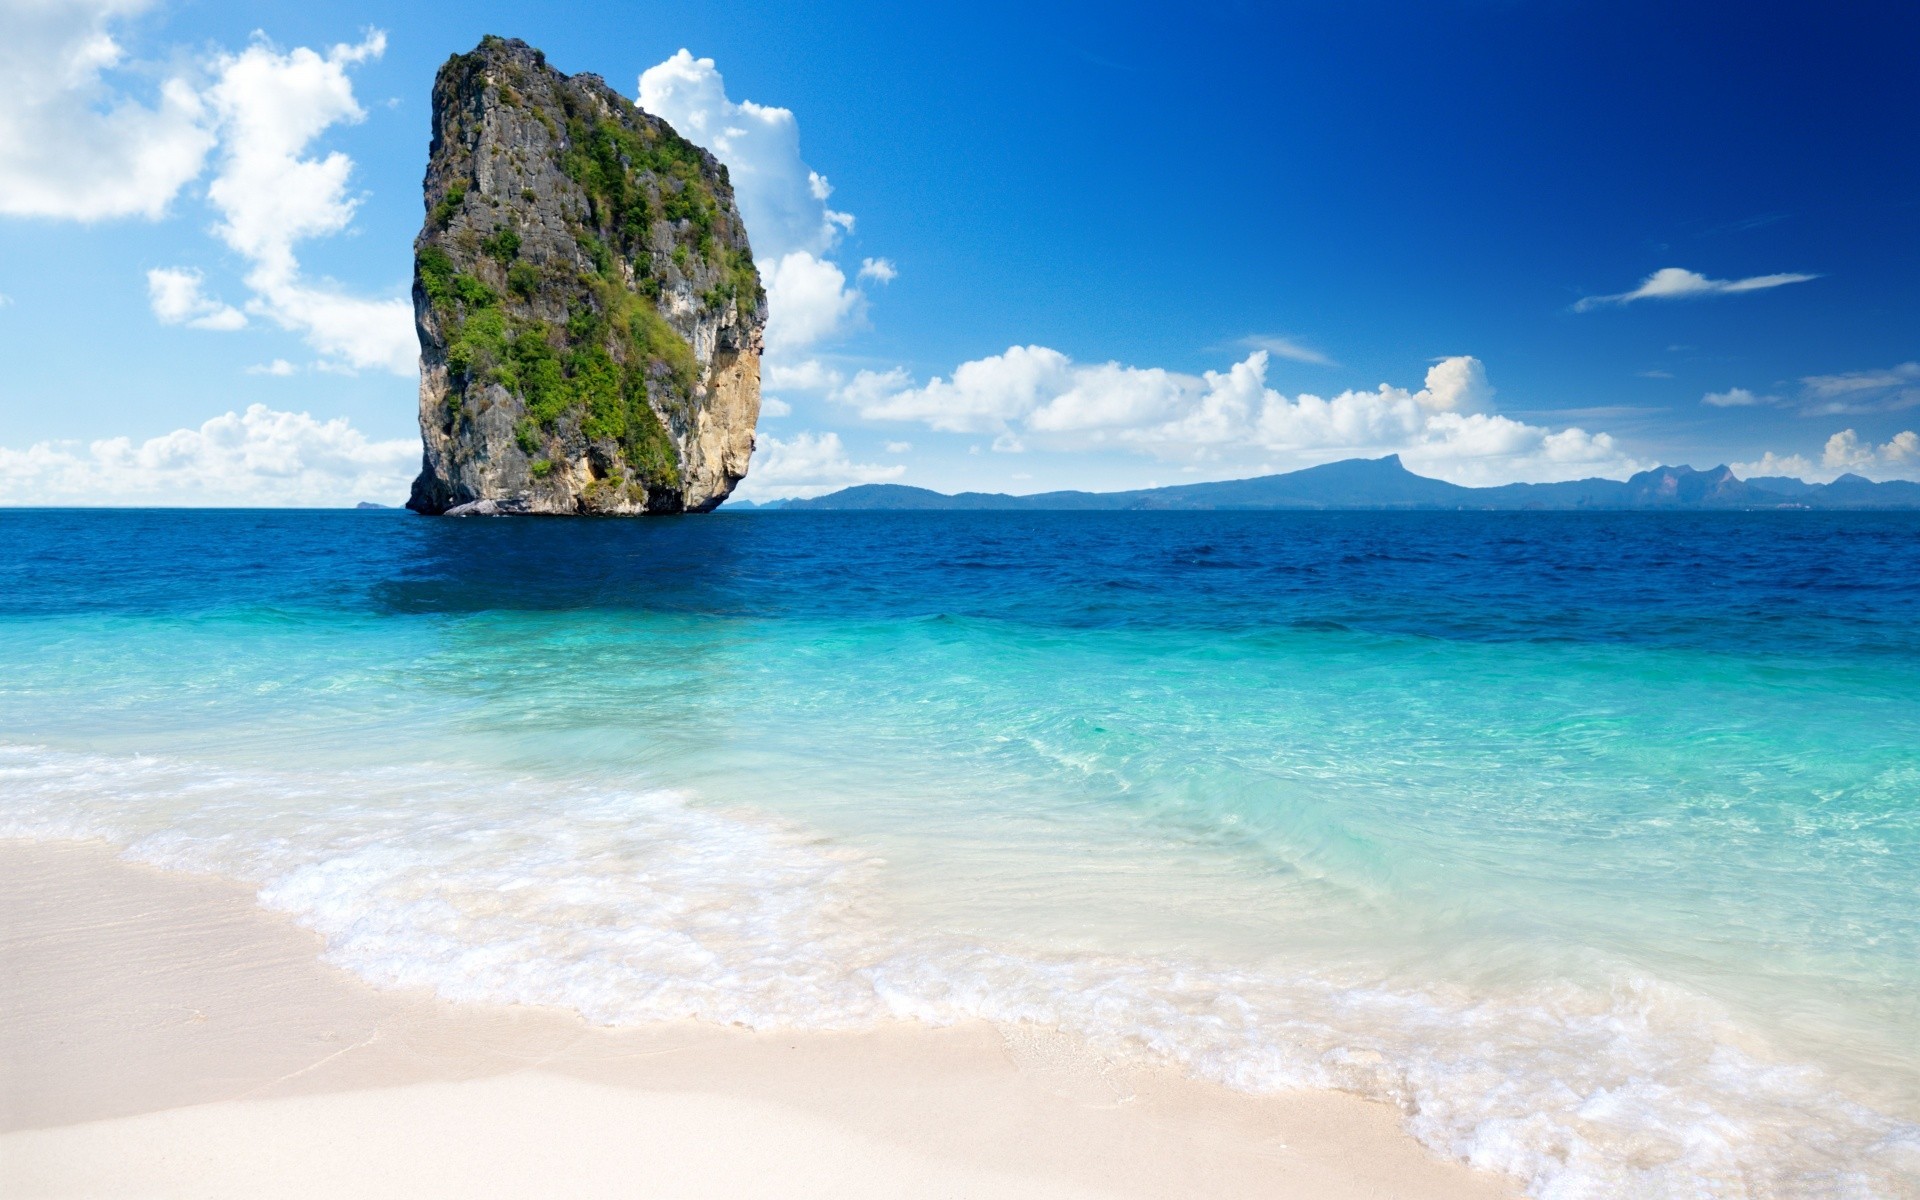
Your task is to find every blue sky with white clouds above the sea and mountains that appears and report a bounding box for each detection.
[0,0,1920,503]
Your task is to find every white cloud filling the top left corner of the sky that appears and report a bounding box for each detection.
[0,0,213,221]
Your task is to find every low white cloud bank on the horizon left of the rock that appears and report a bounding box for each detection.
[0,405,420,507]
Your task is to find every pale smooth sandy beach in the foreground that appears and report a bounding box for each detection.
[0,841,1519,1200]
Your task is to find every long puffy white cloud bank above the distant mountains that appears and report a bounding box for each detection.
[835,346,1642,484]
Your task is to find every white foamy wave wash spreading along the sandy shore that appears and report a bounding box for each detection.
[0,747,1920,1198]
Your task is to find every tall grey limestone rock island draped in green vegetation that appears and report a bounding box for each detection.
[407,38,766,515]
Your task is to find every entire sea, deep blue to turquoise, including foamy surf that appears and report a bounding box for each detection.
[0,513,1920,1196]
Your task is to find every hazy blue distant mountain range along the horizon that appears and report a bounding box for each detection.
[728,455,1920,513]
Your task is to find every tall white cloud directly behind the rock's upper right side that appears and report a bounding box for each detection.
[639,50,893,351]
